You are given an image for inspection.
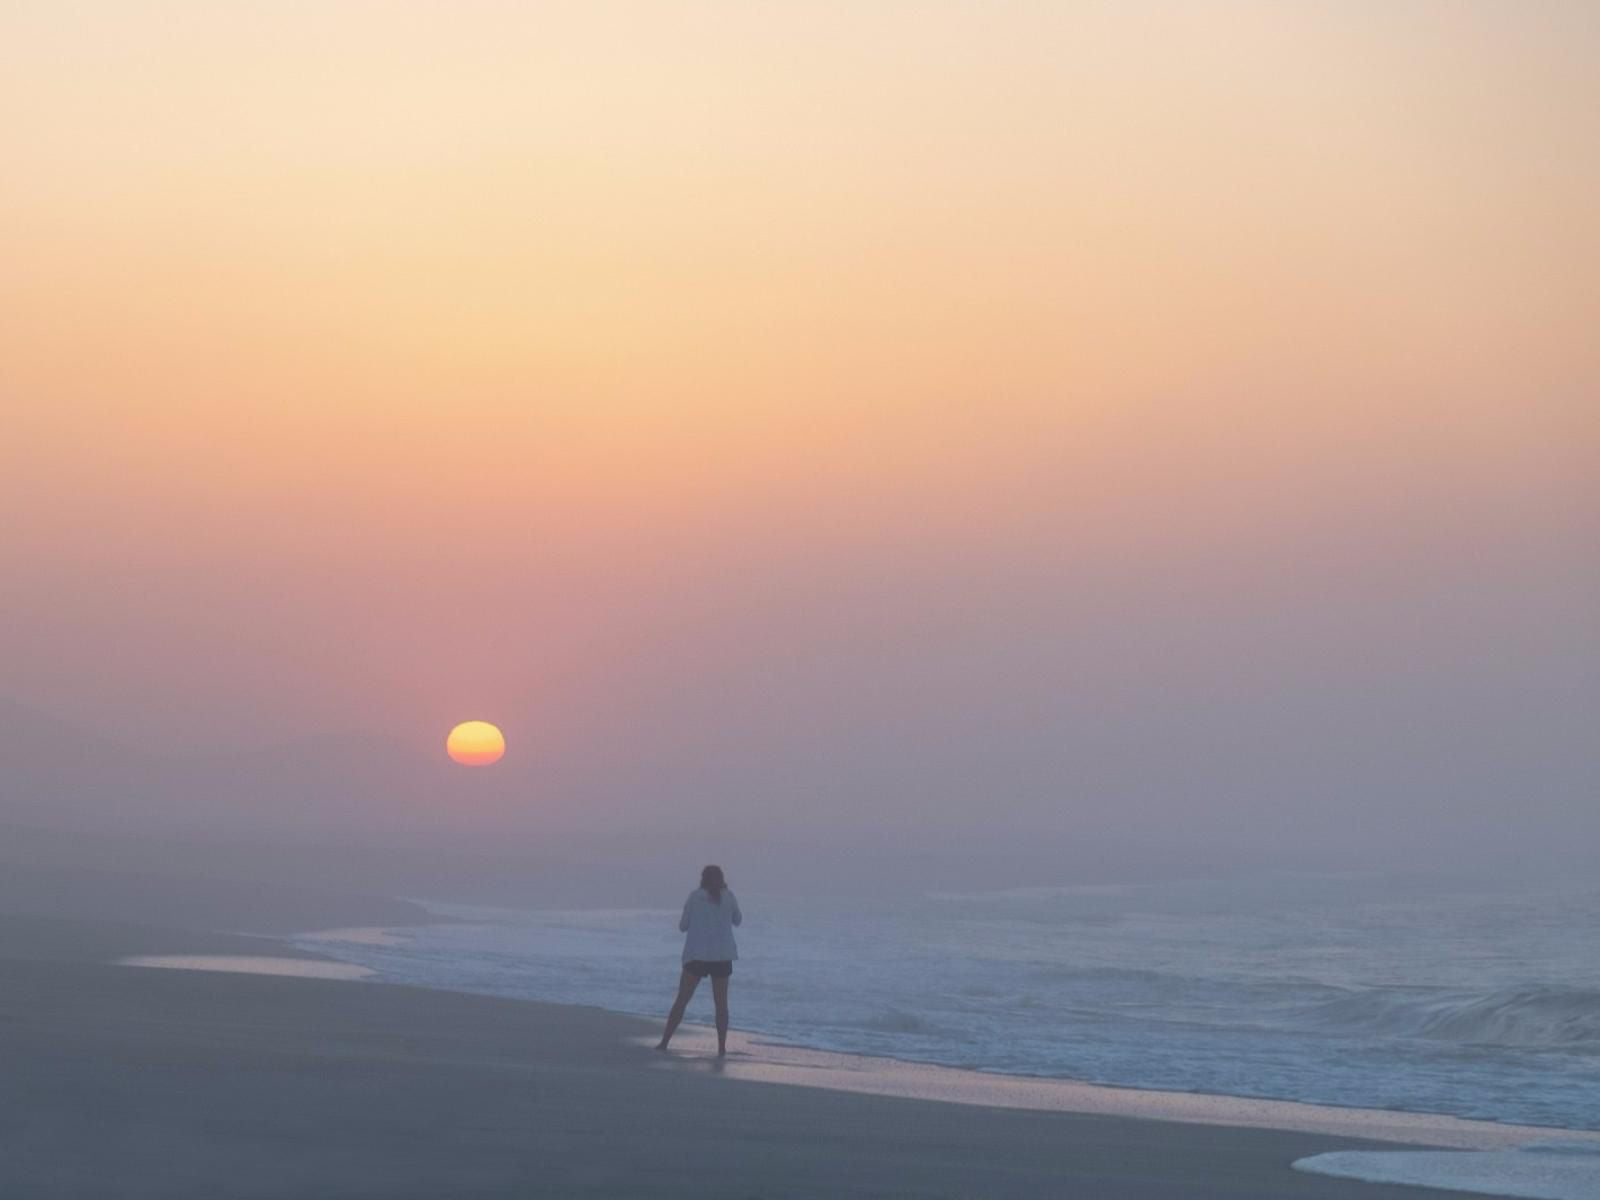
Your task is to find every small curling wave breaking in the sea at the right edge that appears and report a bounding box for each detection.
[1307,987,1600,1050]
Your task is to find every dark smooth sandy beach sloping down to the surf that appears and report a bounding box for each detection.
[0,918,1536,1200]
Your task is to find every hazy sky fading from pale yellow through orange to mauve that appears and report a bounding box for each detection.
[0,0,1600,853]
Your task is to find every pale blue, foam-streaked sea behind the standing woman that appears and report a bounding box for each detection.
[291,875,1600,1130]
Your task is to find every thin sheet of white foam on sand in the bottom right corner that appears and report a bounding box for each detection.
[1294,1141,1600,1200]
